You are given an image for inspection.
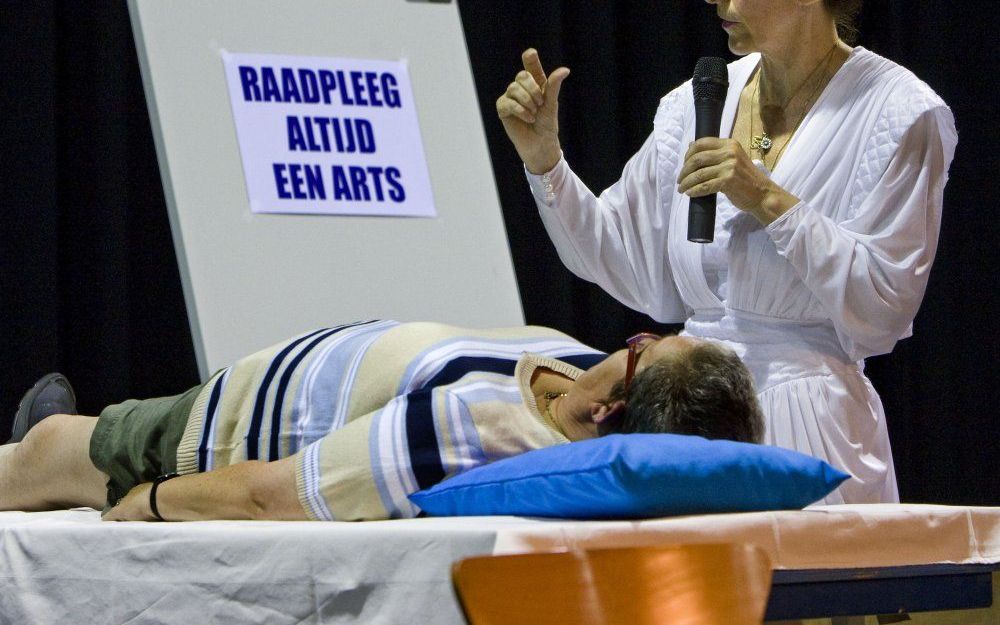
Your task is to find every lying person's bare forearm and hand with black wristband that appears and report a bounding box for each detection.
[104,456,307,521]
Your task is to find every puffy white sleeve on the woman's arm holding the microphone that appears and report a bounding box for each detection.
[767,106,958,359]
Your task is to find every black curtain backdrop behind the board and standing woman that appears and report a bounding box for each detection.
[0,0,1000,505]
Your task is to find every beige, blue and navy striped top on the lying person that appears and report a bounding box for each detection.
[177,321,605,521]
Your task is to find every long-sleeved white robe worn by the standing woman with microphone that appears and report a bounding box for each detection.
[528,48,957,503]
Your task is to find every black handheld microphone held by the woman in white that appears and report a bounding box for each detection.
[688,56,729,243]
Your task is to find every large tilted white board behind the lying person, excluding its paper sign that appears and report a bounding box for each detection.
[129,0,524,378]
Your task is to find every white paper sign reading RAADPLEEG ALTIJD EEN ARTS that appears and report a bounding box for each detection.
[222,51,436,217]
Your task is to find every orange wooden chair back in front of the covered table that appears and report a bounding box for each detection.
[452,545,771,625]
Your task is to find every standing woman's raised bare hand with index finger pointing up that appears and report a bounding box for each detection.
[497,48,569,174]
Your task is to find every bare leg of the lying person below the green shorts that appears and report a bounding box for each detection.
[0,414,108,510]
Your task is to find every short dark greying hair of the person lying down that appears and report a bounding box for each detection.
[600,342,764,443]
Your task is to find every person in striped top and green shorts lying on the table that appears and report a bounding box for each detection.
[0,321,763,521]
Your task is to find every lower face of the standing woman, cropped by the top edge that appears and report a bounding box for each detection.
[705,0,800,56]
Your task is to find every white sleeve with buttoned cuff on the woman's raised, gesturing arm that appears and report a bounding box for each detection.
[525,129,688,322]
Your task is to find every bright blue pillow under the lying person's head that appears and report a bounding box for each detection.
[410,434,850,519]
